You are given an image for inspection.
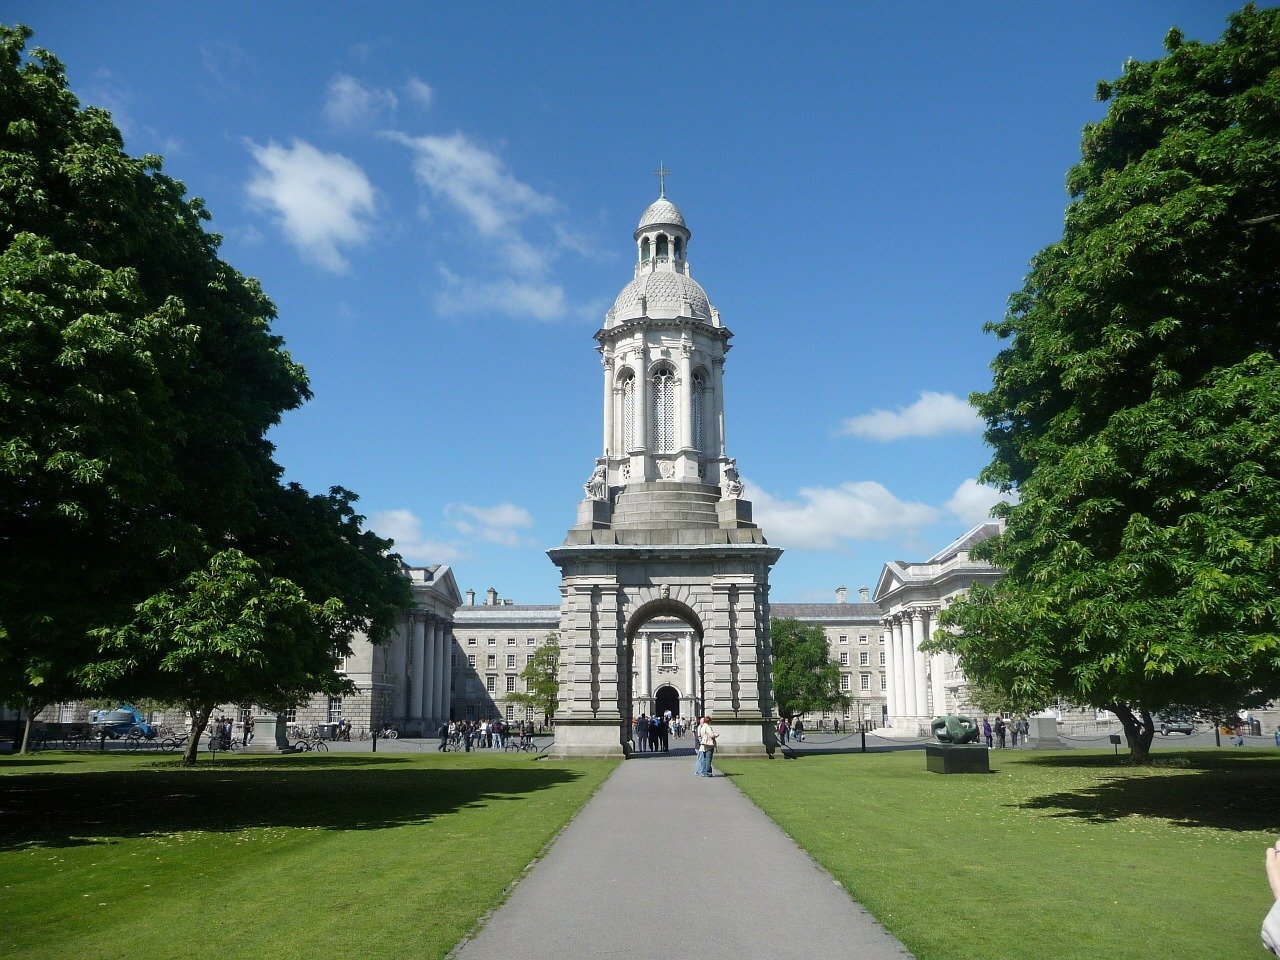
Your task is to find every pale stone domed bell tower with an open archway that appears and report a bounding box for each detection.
[548,184,782,755]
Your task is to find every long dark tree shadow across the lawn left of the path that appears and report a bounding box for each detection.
[0,755,580,850]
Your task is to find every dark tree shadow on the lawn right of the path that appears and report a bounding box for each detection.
[1016,751,1280,833]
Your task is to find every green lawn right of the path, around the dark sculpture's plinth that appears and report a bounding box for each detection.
[717,750,1280,960]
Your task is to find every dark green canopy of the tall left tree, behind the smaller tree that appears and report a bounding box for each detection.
[0,27,408,752]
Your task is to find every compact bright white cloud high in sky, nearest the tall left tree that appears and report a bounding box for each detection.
[246,140,374,273]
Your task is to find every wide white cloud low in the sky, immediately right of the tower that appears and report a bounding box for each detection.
[748,480,938,550]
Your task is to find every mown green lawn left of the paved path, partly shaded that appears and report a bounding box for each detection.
[0,753,614,960]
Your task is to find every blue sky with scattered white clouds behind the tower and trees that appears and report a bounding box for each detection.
[15,0,1235,603]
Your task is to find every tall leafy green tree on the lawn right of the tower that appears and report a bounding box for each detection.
[938,5,1280,760]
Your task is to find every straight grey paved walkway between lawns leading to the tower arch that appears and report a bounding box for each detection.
[454,753,910,960]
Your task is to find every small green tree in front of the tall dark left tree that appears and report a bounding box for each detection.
[87,550,355,764]
